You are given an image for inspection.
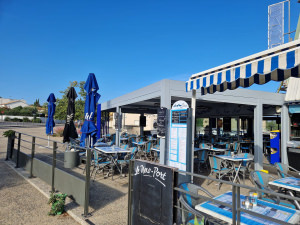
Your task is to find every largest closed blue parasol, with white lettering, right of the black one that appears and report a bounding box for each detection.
[80,73,101,147]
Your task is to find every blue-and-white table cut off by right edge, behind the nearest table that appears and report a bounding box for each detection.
[269,177,300,209]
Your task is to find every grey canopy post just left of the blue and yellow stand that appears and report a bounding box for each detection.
[254,101,263,170]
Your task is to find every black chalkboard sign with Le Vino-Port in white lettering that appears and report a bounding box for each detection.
[130,160,177,225]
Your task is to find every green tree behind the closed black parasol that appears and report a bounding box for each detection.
[54,81,86,120]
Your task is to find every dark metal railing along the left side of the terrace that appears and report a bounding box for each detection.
[6,132,92,217]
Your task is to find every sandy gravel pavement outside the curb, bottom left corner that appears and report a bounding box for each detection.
[0,157,77,225]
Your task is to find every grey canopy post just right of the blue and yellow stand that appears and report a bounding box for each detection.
[280,105,290,164]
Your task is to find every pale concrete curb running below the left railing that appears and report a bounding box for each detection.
[3,160,90,225]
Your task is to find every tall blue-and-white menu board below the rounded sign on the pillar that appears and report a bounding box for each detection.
[169,109,187,171]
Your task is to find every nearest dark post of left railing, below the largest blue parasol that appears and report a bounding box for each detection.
[84,148,91,217]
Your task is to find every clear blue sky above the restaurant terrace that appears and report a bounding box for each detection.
[0,0,300,103]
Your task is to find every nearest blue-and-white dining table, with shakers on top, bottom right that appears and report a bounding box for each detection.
[195,192,300,225]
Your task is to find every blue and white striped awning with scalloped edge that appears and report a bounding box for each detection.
[186,40,300,95]
